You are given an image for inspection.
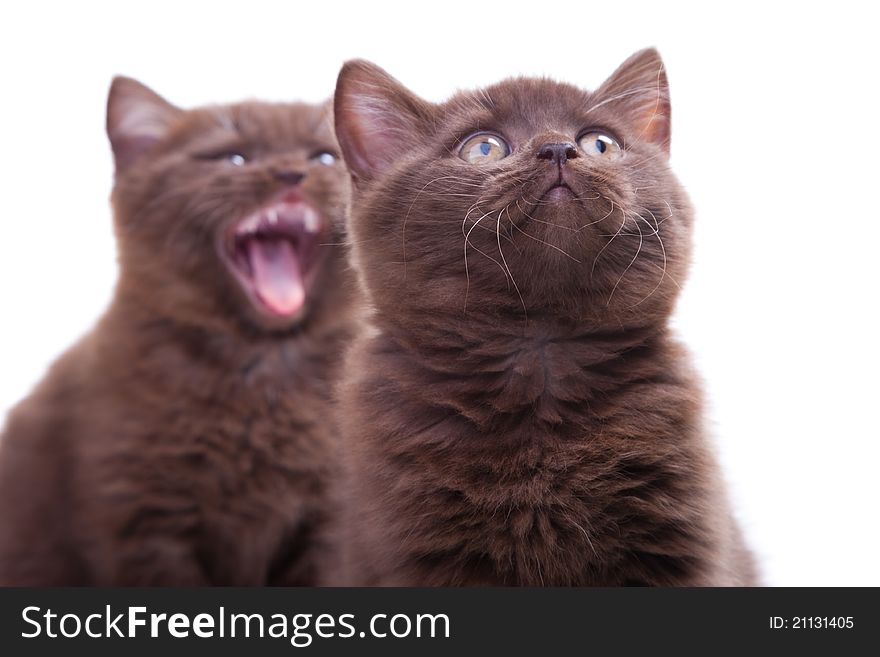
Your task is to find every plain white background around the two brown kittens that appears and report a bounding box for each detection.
[0,0,880,586]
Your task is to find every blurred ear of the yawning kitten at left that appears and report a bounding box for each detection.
[107,76,183,171]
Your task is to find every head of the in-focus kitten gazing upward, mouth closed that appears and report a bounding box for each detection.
[335,50,691,328]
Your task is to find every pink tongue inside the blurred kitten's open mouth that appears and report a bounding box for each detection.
[247,239,306,315]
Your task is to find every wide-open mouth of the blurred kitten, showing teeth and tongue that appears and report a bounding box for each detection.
[222,195,323,319]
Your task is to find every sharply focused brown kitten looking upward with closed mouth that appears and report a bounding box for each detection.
[335,50,755,586]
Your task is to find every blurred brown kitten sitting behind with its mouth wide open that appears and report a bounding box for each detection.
[0,78,353,585]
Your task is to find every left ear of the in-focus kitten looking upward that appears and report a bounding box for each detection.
[334,60,431,182]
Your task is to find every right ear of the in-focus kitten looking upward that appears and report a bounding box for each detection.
[595,48,672,153]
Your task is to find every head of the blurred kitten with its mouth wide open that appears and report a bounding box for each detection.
[107,77,348,332]
